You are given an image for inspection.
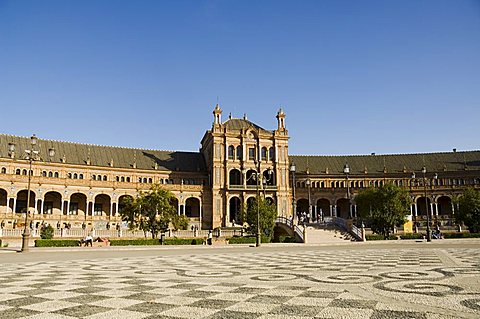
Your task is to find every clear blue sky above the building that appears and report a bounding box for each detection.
[0,0,480,155]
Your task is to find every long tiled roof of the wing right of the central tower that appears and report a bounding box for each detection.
[289,151,480,175]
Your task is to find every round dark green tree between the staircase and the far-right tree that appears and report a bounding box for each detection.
[355,183,411,238]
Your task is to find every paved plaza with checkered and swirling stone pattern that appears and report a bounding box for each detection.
[0,240,480,319]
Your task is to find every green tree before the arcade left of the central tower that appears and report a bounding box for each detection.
[120,184,176,238]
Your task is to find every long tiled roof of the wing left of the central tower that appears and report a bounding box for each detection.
[0,134,206,172]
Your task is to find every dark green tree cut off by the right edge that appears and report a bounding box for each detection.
[455,188,480,233]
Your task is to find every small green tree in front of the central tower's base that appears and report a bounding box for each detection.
[242,198,277,238]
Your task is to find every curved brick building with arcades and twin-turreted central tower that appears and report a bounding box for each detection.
[0,105,480,229]
